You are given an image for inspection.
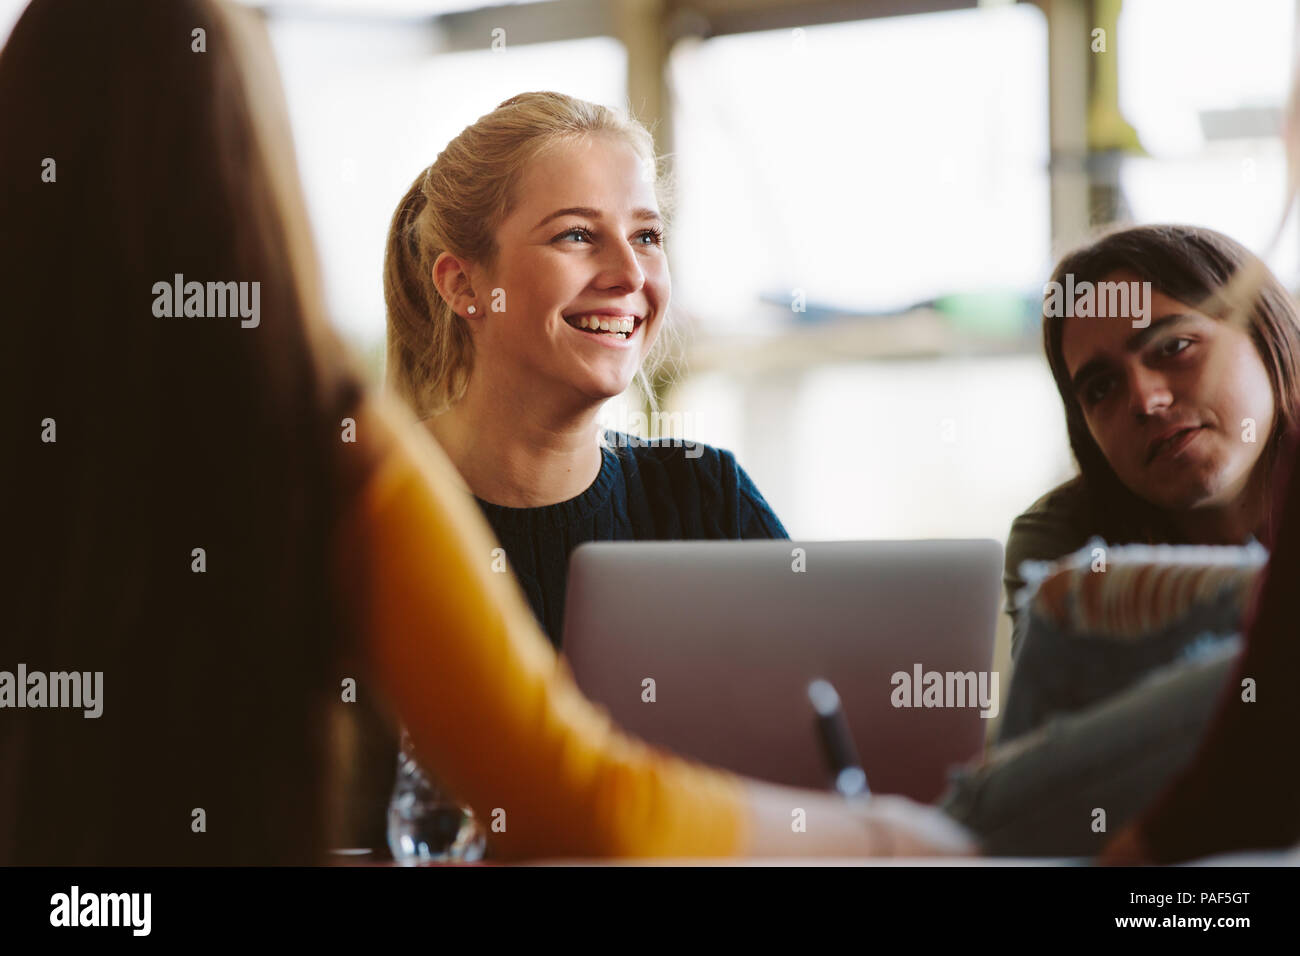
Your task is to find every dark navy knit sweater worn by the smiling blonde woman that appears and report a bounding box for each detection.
[476,432,789,648]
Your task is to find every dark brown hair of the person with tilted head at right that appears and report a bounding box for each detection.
[1043,225,1300,542]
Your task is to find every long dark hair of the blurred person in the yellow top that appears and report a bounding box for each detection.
[0,0,360,864]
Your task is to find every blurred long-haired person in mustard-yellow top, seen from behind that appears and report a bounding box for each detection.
[0,0,970,864]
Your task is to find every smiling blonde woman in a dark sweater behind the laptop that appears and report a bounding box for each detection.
[384,92,787,646]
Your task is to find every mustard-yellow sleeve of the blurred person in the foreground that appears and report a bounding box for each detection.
[339,407,749,860]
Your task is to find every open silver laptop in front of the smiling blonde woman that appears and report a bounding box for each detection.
[562,540,1002,801]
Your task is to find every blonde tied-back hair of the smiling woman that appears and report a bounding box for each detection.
[384,92,670,419]
